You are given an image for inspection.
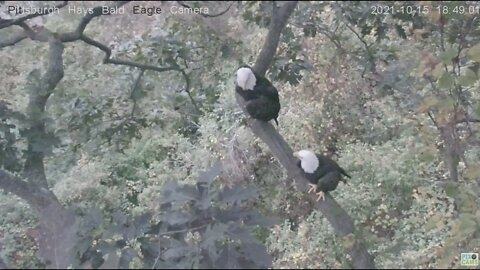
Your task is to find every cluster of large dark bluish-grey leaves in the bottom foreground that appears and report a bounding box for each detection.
[39,163,274,269]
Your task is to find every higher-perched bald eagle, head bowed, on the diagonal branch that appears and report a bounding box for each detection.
[235,65,280,126]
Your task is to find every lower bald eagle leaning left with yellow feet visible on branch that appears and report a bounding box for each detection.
[293,150,351,201]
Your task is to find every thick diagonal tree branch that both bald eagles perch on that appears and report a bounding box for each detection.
[235,2,375,269]
